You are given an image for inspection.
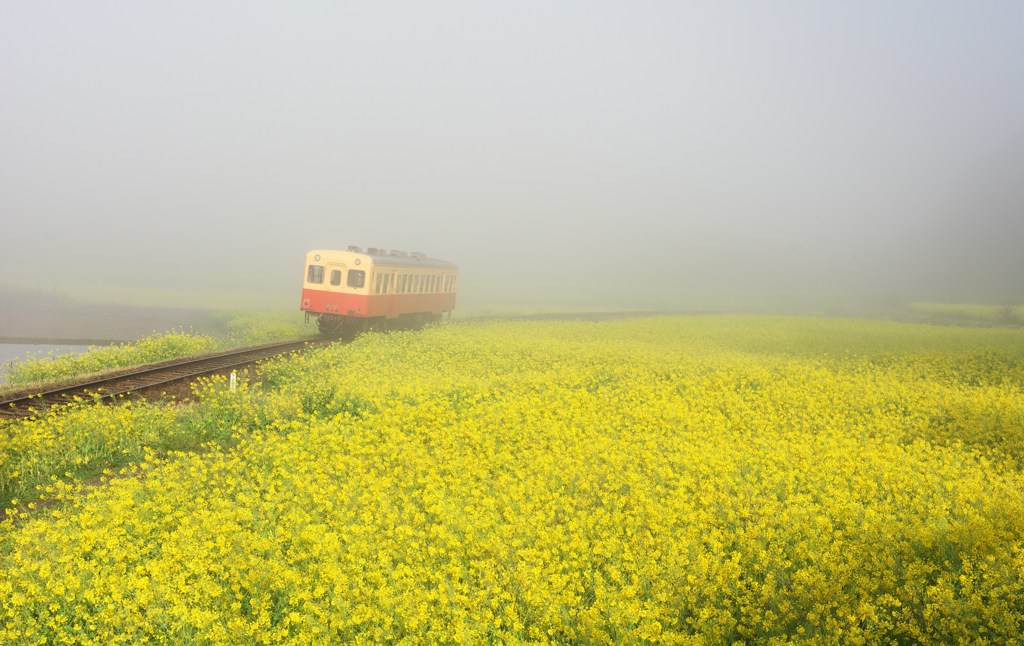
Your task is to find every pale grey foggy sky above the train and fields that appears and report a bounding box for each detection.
[0,0,1024,311]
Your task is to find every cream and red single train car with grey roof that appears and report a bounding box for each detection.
[299,247,459,336]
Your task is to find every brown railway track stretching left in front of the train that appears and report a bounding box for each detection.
[0,339,328,418]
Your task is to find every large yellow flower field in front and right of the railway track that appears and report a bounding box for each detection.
[0,317,1024,644]
